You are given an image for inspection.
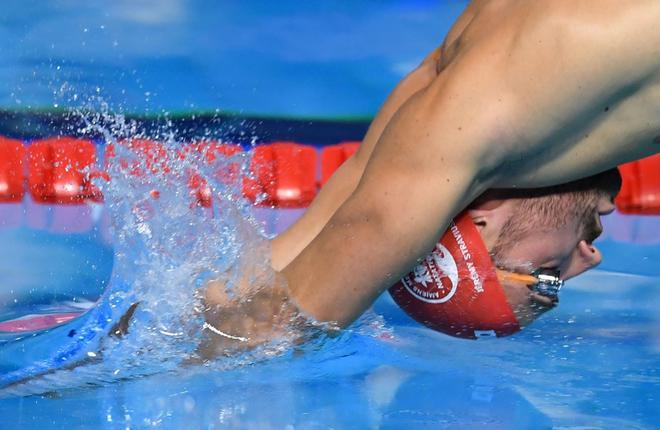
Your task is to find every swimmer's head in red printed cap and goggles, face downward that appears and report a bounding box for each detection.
[390,170,621,339]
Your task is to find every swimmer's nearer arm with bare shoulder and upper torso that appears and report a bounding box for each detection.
[282,0,660,325]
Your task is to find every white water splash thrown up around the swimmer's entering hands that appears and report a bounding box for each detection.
[3,103,336,396]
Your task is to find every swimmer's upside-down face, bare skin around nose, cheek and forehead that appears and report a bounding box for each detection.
[473,197,614,326]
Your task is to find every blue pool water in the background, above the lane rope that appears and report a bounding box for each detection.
[0,0,467,118]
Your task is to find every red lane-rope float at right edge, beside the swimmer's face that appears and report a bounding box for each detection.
[616,155,660,215]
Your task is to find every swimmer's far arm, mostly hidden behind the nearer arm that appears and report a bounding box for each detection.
[271,48,440,270]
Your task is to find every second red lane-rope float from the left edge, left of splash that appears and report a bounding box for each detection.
[28,137,98,204]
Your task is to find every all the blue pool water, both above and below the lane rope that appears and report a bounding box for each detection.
[0,0,660,429]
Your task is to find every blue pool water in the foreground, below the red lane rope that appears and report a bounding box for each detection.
[0,197,660,429]
